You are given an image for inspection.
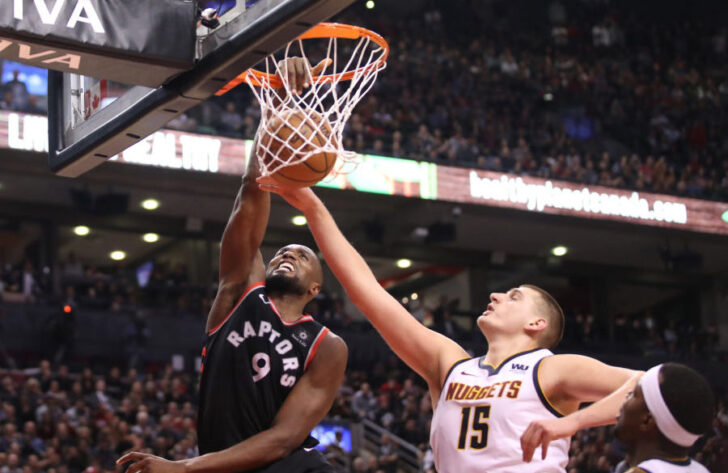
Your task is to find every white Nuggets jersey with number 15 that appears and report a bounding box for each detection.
[430,349,570,473]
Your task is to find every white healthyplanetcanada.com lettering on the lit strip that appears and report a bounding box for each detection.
[470,171,688,225]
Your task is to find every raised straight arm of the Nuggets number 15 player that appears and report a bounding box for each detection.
[262,181,468,393]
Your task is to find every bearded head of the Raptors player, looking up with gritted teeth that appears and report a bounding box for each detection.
[265,244,323,302]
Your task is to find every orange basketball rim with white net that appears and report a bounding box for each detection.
[216,23,389,176]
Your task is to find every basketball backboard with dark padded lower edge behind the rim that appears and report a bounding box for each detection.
[48,0,353,177]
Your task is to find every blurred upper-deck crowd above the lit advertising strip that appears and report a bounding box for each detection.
[0,0,728,200]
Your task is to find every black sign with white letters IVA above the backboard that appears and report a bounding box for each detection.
[0,0,197,87]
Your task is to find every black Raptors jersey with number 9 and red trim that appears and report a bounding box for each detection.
[197,282,328,454]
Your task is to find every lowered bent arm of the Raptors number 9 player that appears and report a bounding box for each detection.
[117,333,348,473]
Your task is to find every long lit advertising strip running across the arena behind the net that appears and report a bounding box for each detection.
[0,111,728,235]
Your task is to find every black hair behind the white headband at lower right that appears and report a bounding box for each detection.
[660,363,715,435]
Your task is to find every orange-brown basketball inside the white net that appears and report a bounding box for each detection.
[259,110,337,187]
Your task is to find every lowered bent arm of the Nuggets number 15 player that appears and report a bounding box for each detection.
[521,355,644,461]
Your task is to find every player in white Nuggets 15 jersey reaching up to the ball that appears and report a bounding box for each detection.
[259,179,641,473]
